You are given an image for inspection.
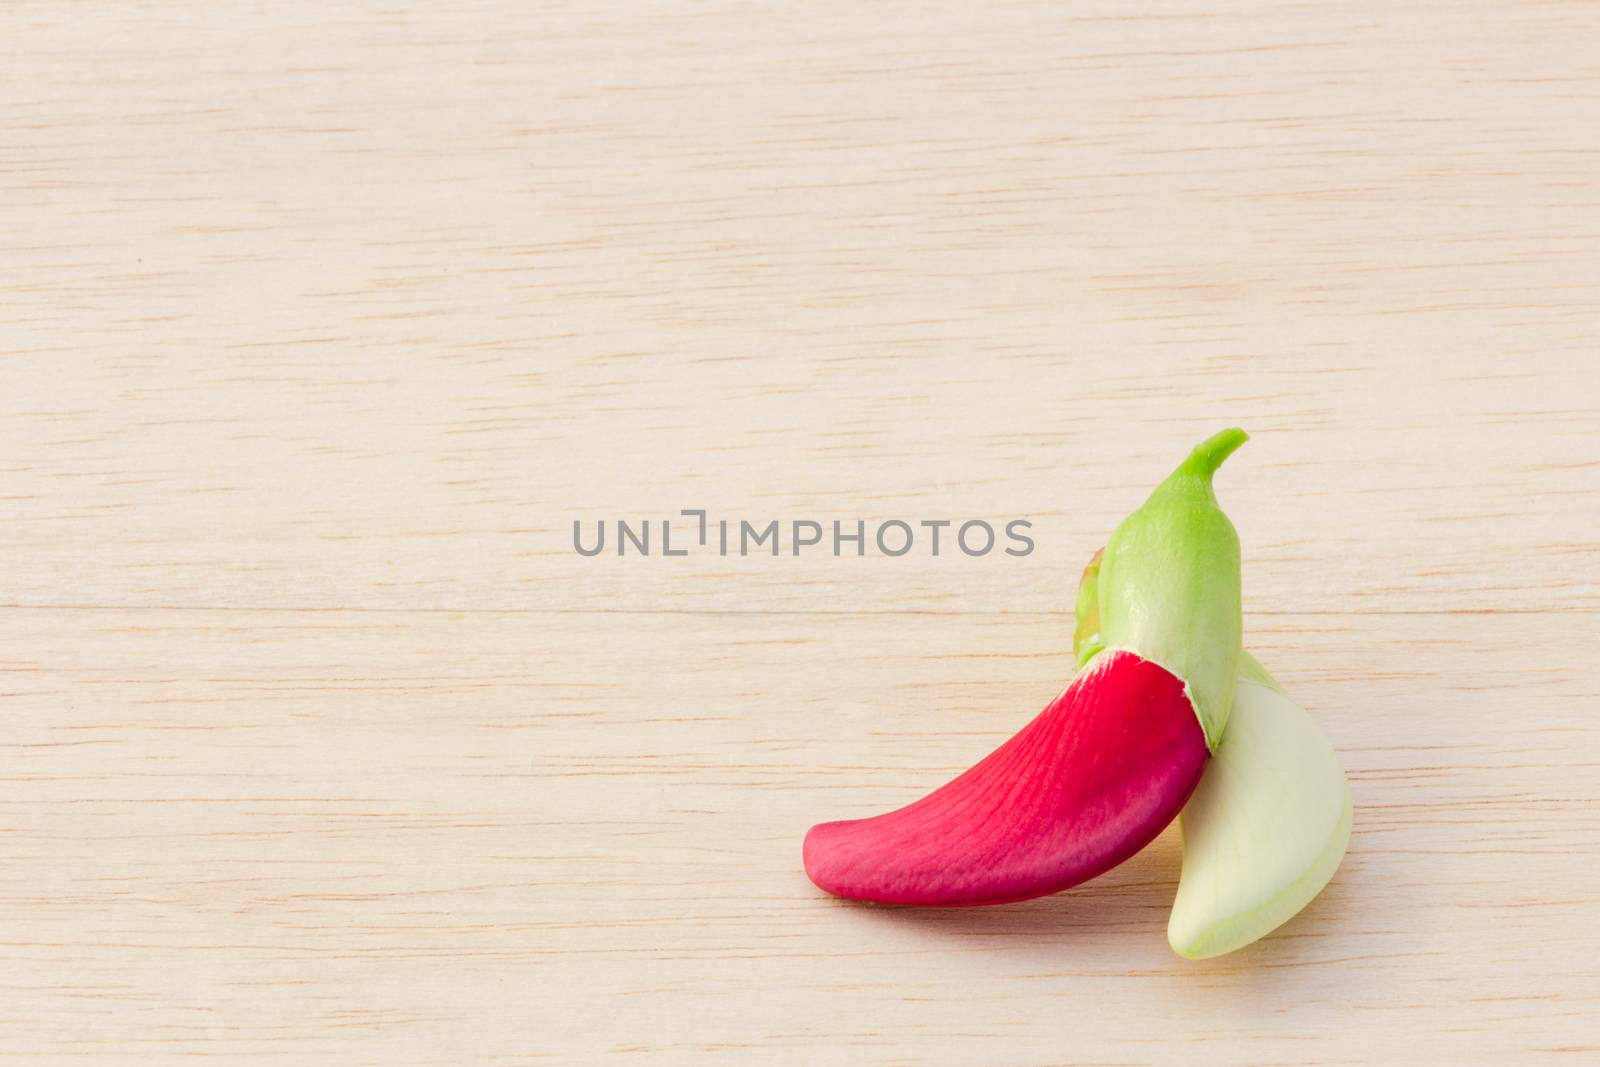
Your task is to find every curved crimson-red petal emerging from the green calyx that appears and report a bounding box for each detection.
[805,653,1206,905]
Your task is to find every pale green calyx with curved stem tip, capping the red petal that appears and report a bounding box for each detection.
[1094,429,1248,752]
